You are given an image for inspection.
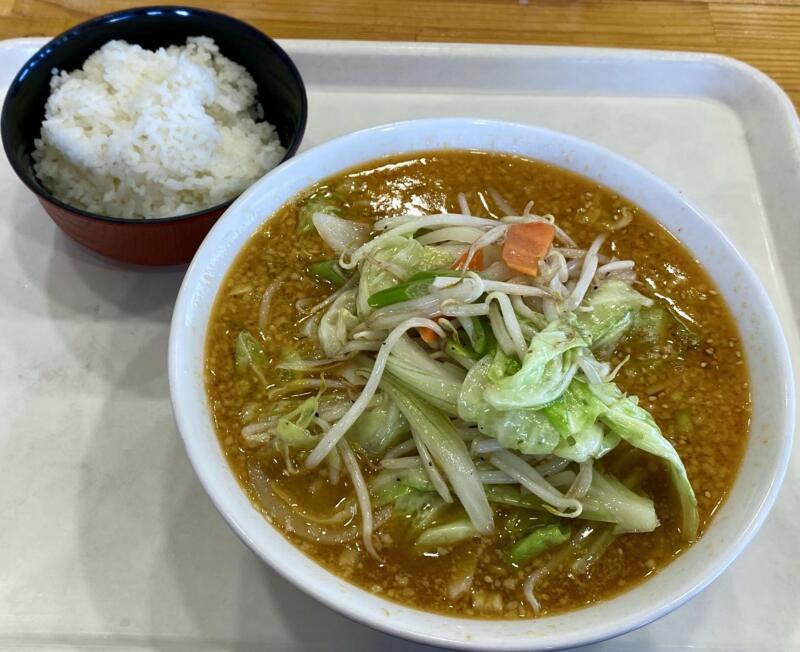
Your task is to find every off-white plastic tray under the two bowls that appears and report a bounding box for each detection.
[0,39,800,652]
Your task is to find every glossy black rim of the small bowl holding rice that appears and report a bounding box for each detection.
[0,5,308,226]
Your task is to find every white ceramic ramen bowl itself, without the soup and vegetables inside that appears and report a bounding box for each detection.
[169,119,795,650]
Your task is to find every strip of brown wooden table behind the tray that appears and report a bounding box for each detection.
[0,0,800,112]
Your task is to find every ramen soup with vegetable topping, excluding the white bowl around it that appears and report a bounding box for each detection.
[206,151,750,618]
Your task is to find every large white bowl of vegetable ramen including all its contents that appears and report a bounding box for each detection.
[169,119,794,650]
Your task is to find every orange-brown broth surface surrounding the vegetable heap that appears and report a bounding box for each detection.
[206,151,750,618]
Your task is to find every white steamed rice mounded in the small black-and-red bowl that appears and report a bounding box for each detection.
[33,37,285,218]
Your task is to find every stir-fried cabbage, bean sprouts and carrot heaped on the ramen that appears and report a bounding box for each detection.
[242,192,699,610]
